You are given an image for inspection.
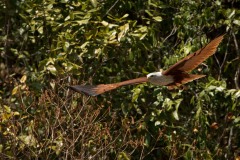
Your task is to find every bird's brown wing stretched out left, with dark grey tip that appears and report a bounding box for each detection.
[69,77,147,96]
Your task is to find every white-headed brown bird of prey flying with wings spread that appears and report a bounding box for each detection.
[69,35,224,96]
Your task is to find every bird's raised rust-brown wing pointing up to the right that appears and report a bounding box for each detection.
[163,35,224,75]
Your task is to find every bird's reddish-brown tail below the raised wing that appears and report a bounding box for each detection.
[167,73,206,89]
